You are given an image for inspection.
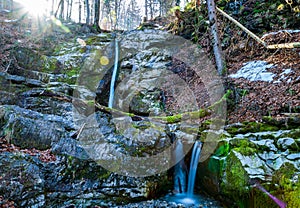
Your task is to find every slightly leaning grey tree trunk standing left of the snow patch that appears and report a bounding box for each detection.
[207,0,224,75]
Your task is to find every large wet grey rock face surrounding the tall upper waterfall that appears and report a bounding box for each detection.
[0,30,217,207]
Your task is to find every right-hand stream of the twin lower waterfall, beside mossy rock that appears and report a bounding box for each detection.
[187,141,202,196]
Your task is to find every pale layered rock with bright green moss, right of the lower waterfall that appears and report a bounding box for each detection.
[198,123,300,207]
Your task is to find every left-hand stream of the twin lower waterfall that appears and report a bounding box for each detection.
[174,139,187,193]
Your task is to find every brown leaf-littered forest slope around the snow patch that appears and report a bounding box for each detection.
[154,11,300,123]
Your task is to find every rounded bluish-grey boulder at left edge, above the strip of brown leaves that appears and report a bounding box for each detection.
[0,106,72,149]
